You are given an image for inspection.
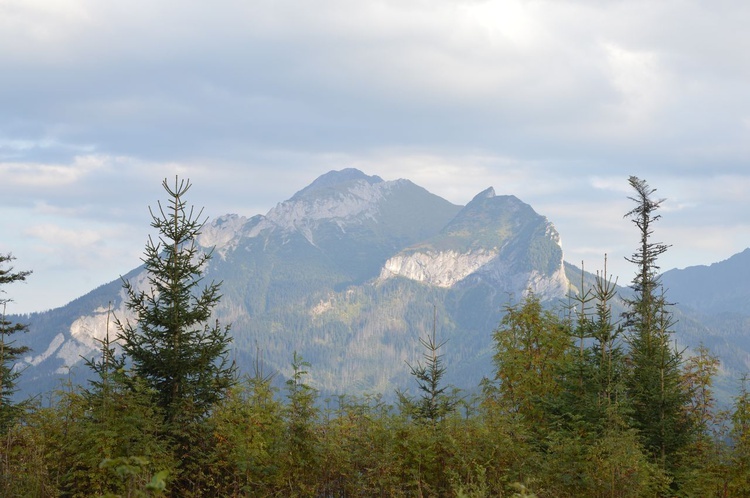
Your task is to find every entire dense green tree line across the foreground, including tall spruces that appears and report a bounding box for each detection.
[0,177,750,497]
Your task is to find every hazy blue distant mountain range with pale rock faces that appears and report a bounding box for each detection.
[11,169,750,402]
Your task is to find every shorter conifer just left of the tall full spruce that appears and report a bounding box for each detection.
[56,311,175,496]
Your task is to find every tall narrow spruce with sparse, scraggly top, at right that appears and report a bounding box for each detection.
[624,176,692,475]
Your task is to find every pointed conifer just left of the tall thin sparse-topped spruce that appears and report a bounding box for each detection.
[539,257,660,497]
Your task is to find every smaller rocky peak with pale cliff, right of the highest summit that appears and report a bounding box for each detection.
[379,188,569,297]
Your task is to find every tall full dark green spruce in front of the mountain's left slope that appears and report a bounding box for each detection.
[116,177,234,425]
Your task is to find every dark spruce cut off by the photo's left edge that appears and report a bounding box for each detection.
[0,254,31,433]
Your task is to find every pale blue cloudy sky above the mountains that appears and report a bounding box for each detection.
[0,0,750,313]
